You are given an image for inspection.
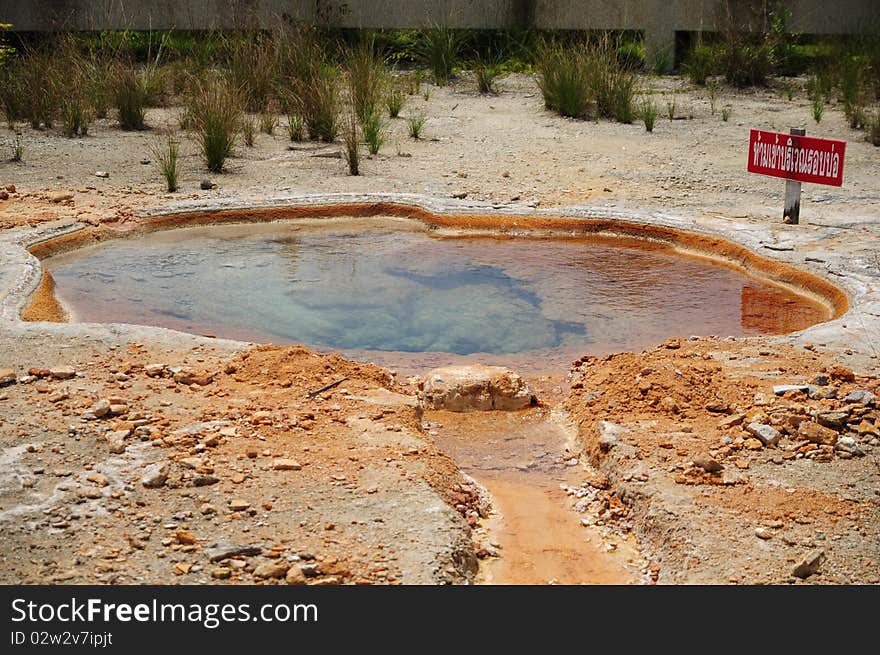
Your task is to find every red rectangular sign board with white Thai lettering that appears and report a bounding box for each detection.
[748,130,846,186]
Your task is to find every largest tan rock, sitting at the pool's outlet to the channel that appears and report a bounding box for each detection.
[419,364,535,412]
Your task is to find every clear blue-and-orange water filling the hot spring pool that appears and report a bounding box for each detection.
[45,219,827,366]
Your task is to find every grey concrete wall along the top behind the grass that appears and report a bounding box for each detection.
[0,0,880,68]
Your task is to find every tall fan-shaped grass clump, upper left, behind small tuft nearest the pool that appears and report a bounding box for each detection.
[187,78,243,173]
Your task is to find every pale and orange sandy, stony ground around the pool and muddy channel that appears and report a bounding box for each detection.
[0,76,880,583]
